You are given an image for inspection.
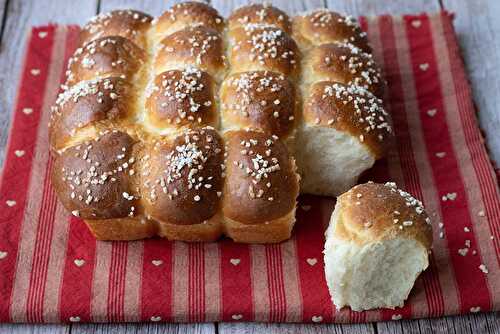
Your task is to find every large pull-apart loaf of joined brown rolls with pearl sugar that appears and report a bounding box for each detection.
[49,2,392,243]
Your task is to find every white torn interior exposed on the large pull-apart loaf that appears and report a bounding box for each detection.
[296,126,375,196]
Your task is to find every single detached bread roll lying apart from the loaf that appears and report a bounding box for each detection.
[324,183,432,311]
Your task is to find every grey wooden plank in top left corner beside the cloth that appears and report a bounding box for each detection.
[0,0,97,164]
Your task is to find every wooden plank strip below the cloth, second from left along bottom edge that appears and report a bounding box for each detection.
[71,323,215,334]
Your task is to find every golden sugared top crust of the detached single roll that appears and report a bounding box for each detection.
[335,183,432,250]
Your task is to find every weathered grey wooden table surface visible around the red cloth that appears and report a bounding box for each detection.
[0,0,500,334]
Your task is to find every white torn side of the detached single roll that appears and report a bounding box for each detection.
[324,208,428,311]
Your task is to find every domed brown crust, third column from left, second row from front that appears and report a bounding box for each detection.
[220,71,297,137]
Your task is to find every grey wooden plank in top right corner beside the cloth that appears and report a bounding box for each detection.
[443,0,500,165]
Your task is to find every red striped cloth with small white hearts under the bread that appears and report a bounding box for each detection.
[0,13,500,322]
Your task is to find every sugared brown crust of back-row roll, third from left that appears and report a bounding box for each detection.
[227,3,292,33]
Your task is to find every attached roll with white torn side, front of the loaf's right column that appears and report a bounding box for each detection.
[295,81,393,195]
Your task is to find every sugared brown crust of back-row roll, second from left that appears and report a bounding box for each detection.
[154,1,224,38]
